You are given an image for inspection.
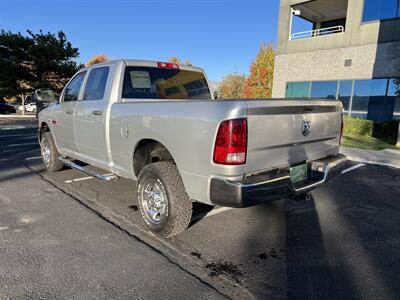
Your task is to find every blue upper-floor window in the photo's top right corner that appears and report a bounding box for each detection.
[363,0,398,22]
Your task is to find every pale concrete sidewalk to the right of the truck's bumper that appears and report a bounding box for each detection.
[340,147,400,168]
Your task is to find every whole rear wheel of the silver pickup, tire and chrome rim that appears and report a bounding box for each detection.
[137,162,192,237]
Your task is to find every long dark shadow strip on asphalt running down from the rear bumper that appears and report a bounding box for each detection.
[285,199,340,299]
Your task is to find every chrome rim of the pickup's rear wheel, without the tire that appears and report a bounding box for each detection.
[141,179,168,224]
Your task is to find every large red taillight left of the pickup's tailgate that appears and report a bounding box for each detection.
[214,118,247,165]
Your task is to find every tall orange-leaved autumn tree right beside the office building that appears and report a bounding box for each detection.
[243,44,275,98]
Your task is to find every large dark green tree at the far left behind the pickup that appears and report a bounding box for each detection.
[0,30,80,99]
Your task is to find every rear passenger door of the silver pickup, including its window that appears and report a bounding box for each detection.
[75,66,112,165]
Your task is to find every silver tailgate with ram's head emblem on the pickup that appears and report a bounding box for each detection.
[246,100,342,174]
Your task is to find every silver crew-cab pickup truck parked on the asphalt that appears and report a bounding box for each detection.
[39,60,345,237]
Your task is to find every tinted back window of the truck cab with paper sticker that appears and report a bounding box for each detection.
[122,67,211,99]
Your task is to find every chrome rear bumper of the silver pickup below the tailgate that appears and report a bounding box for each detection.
[210,154,346,207]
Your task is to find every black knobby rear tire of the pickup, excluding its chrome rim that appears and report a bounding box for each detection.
[137,162,192,237]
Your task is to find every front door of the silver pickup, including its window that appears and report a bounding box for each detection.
[52,71,86,154]
